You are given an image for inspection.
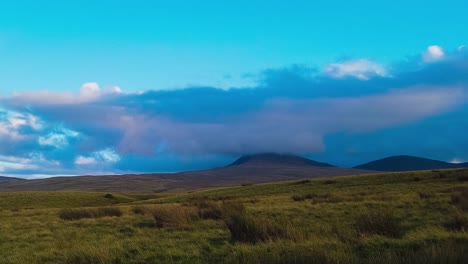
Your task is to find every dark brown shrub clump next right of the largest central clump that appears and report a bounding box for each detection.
[354,209,403,238]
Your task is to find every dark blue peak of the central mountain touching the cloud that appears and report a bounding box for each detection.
[228,153,335,167]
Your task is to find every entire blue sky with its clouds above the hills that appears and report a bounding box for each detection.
[0,0,468,178]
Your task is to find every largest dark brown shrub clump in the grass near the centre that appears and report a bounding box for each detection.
[224,203,303,243]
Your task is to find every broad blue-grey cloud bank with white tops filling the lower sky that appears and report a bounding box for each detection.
[0,46,468,177]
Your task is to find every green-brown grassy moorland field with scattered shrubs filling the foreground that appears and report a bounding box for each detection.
[0,169,468,263]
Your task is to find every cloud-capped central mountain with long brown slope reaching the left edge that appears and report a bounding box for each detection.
[0,153,375,192]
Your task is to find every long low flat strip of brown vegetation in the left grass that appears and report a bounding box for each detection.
[59,207,123,220]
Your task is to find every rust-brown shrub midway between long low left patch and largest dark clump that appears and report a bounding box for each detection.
[152,206,198,228]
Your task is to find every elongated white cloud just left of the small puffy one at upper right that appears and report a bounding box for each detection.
[323,59,388,80]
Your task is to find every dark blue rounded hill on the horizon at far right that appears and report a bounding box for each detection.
[354,155,462,171]
